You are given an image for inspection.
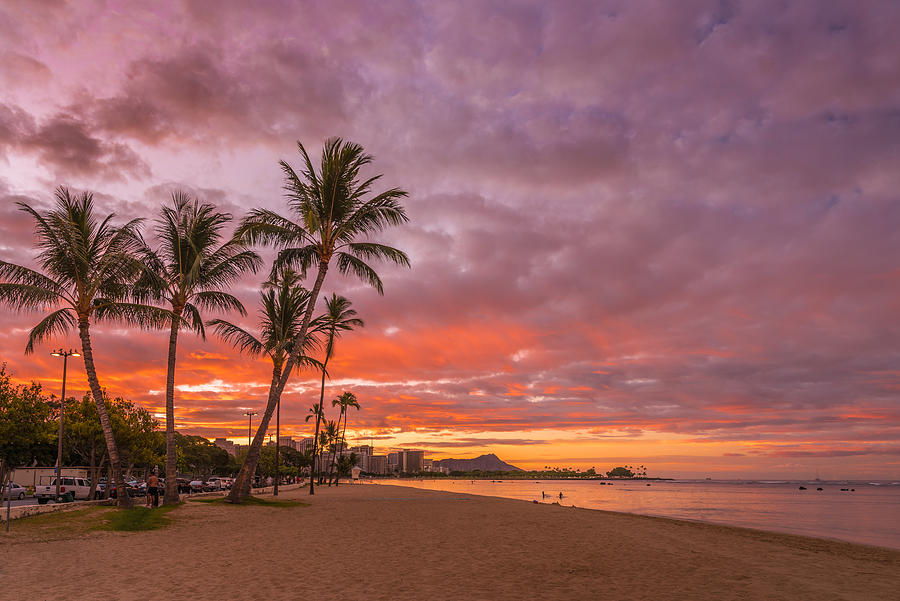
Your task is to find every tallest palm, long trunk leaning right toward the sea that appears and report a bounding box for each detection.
[229,138,409,503]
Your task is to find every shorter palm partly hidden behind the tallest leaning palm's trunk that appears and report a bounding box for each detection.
[209,269,321,493]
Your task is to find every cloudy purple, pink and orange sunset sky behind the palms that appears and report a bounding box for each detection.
[0,0,900,479]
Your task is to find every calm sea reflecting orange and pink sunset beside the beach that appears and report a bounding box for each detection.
[378,479,900,549]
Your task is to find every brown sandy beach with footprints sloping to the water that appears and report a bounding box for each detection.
[0,484,900,601]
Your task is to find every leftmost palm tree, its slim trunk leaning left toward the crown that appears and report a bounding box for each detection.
[0,186,169,507]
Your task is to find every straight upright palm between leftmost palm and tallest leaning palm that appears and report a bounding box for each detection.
[136,191,262,504]
